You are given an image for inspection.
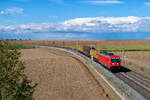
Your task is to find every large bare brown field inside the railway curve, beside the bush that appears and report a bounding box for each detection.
[21,48,111,100]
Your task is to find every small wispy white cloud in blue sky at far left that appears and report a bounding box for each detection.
[0,7,24,15]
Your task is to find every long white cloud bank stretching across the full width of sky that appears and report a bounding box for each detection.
[0,16,150,38]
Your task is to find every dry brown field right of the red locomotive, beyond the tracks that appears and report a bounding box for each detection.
[115,51,150,76]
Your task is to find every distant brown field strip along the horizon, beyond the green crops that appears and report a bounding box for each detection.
[6,40,150,47]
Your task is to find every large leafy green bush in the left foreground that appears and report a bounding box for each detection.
[0,41,37,100]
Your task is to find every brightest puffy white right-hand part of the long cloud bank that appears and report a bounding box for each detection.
[59,16,150,32]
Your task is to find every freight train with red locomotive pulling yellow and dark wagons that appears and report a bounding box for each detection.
[78,46,121,70]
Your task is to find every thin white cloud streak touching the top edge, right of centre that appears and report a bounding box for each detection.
[87,0,124,4]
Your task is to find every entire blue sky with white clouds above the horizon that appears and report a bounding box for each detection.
[0,0,150,40]
